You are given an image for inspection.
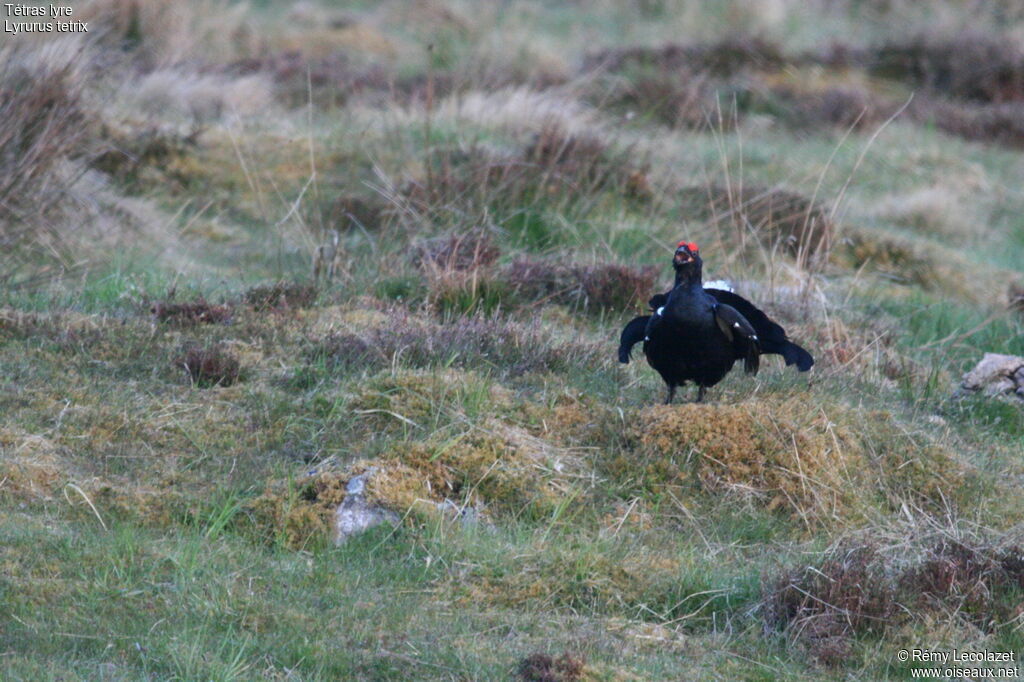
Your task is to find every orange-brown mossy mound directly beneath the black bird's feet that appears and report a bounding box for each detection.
[606,394,973,525]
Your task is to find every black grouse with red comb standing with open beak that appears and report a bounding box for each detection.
[618,242,814,404]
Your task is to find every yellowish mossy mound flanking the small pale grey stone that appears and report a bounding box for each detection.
[243,421,578,548]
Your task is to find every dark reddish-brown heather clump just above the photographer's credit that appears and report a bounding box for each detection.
[765,529,1024,666]
